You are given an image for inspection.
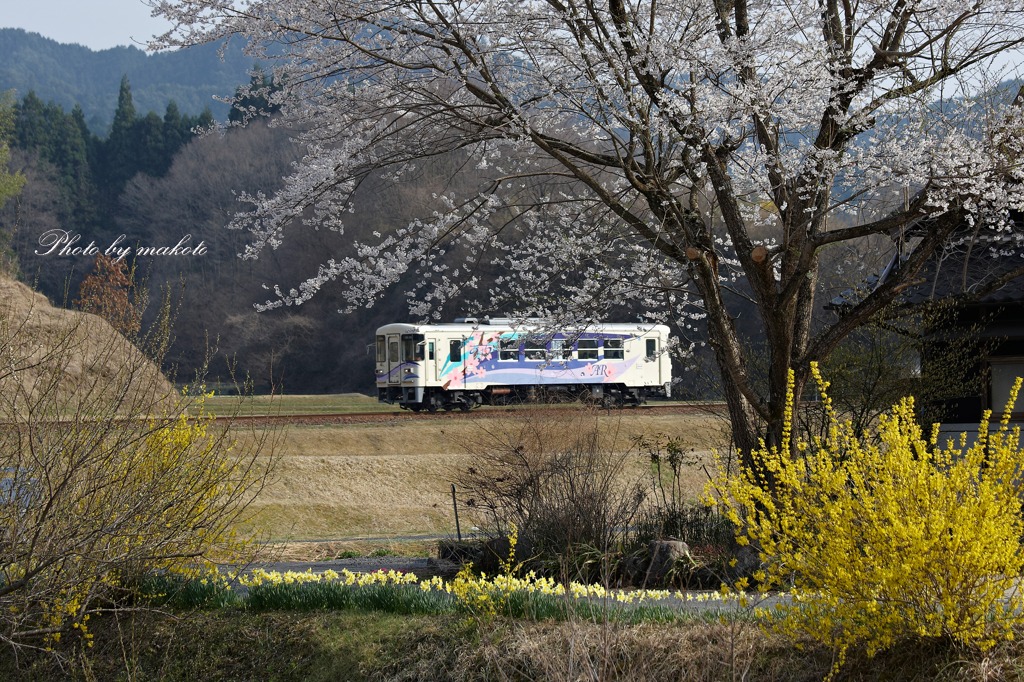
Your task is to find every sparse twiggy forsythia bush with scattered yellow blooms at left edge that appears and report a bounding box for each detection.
[0,387,265,646]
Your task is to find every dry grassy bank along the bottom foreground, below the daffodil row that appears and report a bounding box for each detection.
[6,609,1024,682]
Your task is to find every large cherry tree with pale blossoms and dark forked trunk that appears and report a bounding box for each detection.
[151,0,1024,452]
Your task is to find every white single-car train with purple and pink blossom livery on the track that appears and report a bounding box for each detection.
[375,317,672,412]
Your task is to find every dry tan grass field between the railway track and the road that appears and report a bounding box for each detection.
[209,394,726,546]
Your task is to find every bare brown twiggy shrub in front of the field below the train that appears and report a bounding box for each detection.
[456,409,645,582]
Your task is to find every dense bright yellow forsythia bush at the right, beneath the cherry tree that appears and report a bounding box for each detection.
[713,360,1024,672]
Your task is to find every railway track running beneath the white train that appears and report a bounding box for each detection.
[215,402,725,426]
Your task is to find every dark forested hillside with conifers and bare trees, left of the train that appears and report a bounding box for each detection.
[0,73,479,392]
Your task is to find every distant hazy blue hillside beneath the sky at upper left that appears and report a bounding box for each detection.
[0,29,253,129]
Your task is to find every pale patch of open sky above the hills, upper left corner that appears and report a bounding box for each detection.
[0,0,170,50]
